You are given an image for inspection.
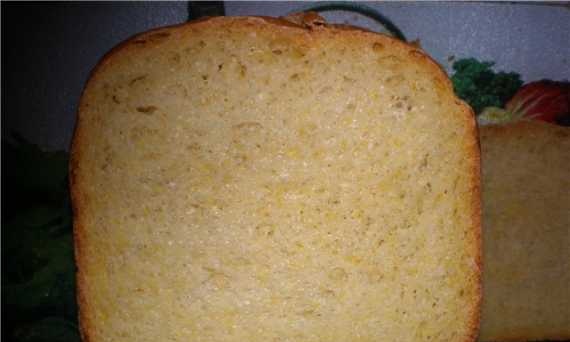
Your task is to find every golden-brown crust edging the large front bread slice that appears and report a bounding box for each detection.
[69,13,482,342]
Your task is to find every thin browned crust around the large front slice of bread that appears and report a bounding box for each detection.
[70,14,482,342]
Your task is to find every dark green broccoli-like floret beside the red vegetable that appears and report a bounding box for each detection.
[451,58,523,114]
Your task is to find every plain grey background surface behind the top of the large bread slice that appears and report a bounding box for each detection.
[2,2,570,149]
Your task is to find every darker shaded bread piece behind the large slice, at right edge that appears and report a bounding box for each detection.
[480,121,570,341]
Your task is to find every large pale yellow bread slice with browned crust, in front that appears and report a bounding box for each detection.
[71,17,481,342]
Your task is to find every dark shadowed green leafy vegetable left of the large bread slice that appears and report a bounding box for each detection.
[1,138,80,342]
